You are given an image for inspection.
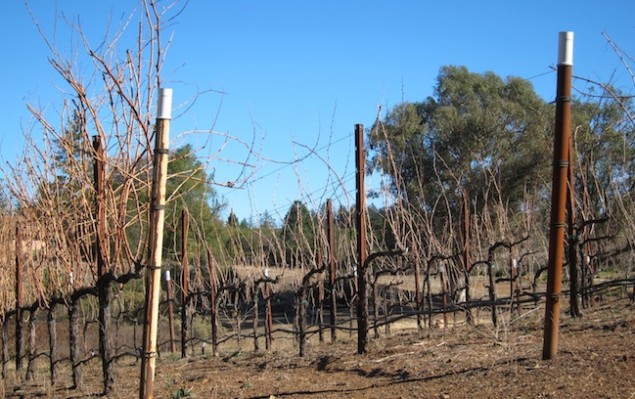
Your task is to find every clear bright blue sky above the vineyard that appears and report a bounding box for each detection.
[0,0,635,222]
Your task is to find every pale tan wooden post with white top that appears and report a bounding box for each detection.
[139,89,172,399]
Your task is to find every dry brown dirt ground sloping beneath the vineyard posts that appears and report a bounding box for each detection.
[2,299,635,399]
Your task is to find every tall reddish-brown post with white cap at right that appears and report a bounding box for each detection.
[542,32,573,360]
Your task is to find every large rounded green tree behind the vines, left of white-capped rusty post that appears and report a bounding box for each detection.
[369,66,551,231]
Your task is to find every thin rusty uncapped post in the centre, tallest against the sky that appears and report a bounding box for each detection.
[355,124,368,354]
